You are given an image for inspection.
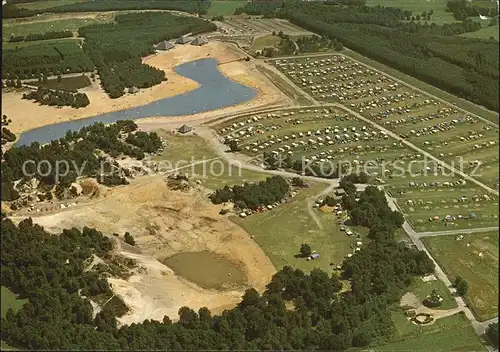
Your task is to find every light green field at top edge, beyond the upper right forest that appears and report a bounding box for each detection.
[366,0,458,24]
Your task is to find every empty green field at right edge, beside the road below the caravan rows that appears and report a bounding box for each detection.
[424,232,498,321]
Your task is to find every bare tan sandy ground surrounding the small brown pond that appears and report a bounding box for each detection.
[13,176,275,324]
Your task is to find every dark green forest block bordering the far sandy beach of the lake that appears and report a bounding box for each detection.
[79,12,215,98]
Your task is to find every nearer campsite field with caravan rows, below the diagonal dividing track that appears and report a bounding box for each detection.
[216,105,498,231]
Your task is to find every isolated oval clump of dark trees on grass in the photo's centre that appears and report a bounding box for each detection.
[210,176,290,210]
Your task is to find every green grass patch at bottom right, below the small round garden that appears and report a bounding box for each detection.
[372,308,486,352]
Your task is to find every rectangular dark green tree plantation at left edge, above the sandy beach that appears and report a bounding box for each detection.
[2,41,95,79]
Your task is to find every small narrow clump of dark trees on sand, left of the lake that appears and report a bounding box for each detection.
[23,86,90,109]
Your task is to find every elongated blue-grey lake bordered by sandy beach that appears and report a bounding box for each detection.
[16,58,257,146]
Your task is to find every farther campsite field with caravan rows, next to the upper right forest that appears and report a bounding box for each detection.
[272,55,499,188]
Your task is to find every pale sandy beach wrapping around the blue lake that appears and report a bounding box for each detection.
[2,42,287,133]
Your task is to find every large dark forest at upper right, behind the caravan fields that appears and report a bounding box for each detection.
[238,1,500,111]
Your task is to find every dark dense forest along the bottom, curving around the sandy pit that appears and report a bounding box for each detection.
[1,184,434,351]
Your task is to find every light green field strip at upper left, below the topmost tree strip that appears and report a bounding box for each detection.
[2,18,99,41]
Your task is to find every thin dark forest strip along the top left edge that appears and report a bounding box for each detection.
[2,0,210,18]
